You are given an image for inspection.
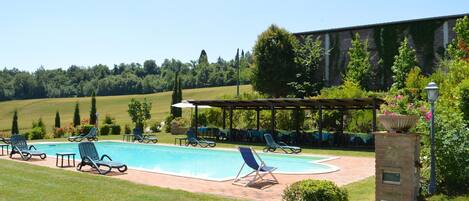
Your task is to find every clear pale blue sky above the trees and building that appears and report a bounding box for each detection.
[0,0,469,71]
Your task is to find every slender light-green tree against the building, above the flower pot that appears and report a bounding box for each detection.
[391,37,417,89]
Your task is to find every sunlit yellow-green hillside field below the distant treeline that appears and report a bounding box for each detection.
[0,85,251,131]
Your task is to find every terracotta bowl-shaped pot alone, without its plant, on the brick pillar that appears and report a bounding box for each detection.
[378,114,419,133]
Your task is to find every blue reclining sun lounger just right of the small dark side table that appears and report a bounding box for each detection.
[77,142,127,175]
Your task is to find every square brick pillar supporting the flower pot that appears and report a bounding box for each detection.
[373,132,420,201]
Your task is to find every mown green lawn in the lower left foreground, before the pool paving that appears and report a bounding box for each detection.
[0,159,236,201]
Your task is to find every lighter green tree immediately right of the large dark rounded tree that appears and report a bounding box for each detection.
[290,36,324,98]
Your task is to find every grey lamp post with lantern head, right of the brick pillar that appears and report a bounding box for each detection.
[425,82,438,194]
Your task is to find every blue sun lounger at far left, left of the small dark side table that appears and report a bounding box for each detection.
[10,134,47,161]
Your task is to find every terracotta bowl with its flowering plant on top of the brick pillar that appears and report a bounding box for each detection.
[378,95,427,133]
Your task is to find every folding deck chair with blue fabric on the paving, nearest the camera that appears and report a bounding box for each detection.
[233,147,278,186]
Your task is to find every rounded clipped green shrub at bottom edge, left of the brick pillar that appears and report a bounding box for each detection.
[283,179,348,201]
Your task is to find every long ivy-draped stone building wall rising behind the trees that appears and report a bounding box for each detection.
[294,13,469,89]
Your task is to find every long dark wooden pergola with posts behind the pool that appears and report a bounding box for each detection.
[188,97,384,141]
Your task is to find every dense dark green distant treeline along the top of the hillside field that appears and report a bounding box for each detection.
[0,50,252,100]
